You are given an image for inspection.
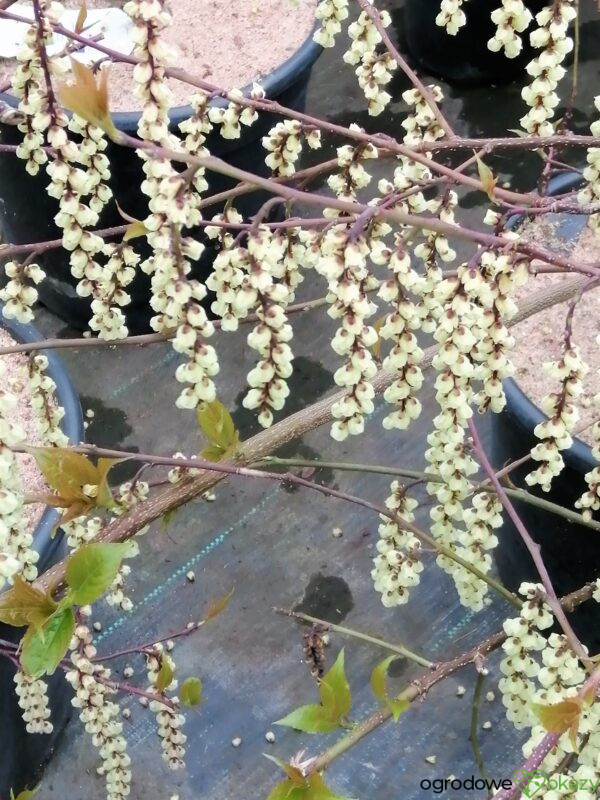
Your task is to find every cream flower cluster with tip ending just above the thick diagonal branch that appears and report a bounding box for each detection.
[242,226,293,428]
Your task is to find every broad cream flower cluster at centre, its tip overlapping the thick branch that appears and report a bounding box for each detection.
[315,231,377,442]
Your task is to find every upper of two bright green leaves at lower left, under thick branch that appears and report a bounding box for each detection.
[65,542,133,606]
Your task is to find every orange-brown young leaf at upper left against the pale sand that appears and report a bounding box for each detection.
[58,59,122,142]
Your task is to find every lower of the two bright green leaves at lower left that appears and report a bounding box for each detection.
[21,608,75,678]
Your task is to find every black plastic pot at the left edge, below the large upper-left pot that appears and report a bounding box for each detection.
[0,310,83,800]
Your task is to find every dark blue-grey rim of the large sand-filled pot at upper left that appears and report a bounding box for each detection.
[0,23,323,132]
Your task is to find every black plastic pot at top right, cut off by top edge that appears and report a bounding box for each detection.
[404,0,546,85]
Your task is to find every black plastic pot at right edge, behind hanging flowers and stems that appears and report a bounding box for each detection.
[492,175,600,652]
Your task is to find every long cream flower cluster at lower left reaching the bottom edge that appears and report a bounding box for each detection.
[66,624,131,800]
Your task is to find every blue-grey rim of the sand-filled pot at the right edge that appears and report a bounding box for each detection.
[502,172,598,472]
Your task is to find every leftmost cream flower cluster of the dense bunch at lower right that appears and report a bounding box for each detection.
[498,583,553,728]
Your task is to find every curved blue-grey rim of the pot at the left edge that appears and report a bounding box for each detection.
[0,312,84,566]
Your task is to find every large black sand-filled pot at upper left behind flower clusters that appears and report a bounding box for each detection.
[0,34,322,333]
